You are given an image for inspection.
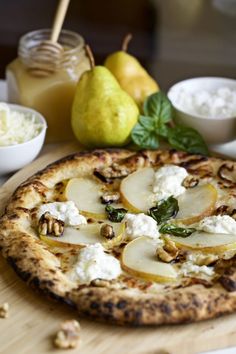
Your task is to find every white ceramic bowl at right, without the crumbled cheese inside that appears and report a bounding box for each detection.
[167,77,236,144]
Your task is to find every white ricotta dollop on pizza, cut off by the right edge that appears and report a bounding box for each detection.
[197,215,236,235]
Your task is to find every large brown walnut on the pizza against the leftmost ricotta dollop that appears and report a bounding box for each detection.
[38,212,65,236]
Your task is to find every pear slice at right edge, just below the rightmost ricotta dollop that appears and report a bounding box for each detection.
[171,231,236,253]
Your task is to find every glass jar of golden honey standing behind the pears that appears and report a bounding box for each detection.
[6,29,90,142]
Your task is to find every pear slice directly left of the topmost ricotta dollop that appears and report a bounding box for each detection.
[120,167,154,213]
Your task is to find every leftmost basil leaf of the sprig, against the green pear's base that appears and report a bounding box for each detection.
[131,123,159,150]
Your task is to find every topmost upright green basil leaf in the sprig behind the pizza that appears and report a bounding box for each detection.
[143,91,173,123]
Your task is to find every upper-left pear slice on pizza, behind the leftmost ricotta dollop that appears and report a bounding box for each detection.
[65,178,106,219]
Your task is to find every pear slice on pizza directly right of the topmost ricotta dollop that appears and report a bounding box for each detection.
[175,184,217,225]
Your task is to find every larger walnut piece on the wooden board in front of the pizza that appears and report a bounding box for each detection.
[54,320,80,349]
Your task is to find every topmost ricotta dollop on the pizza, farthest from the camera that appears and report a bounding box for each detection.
[152,165,188,201]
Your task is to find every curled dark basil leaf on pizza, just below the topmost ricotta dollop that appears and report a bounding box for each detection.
[148,196,179,224]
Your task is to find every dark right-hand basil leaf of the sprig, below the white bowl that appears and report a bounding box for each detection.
[168,125,209,155]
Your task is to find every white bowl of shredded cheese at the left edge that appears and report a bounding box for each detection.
[0,102,47,175]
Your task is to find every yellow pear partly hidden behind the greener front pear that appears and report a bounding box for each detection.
[104,34,159,107]
